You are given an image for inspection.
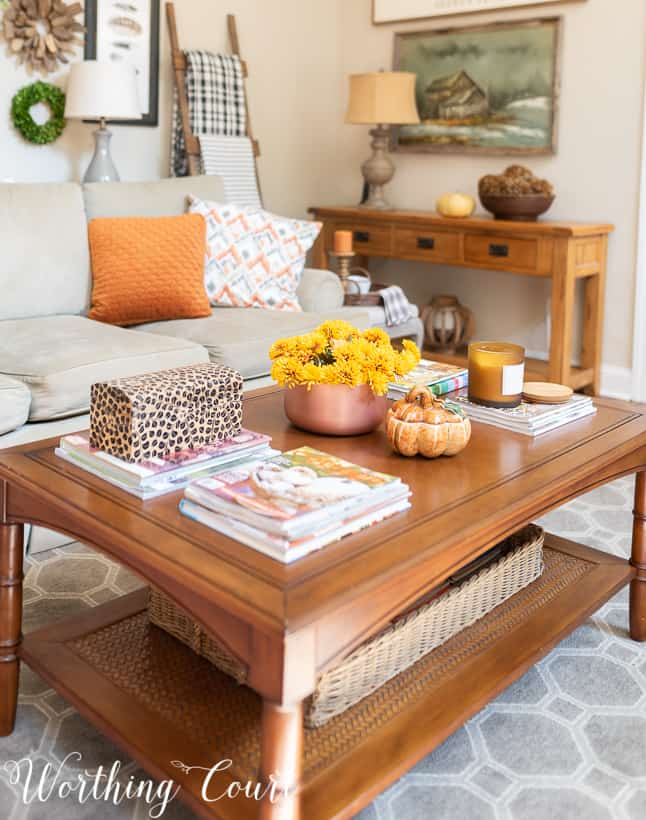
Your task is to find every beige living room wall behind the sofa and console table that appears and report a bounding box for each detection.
[0,0,646,378]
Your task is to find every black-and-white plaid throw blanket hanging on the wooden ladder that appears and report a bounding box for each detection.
[170,51,247,177]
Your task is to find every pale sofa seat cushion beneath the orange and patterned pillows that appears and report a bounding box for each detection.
[137,307,370,379]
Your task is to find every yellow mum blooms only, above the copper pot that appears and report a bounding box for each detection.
[269,320,420,396]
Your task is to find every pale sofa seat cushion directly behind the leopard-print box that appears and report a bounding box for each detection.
[0,316,209,421]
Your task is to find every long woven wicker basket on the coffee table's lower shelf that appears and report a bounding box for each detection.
[149,524,544,727]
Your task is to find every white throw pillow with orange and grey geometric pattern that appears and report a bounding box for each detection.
[189,196,321,310]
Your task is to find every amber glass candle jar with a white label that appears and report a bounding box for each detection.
[469,342,525,407]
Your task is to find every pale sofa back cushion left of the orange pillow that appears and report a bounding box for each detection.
[0,182,90,320]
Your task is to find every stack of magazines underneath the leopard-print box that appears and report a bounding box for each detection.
[56,429,278,501]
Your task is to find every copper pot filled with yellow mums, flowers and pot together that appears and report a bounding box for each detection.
[269,321,420,436]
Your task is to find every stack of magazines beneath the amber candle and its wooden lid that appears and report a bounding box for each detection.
[447,391,597,436]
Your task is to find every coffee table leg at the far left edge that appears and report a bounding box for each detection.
[0,524,23,737]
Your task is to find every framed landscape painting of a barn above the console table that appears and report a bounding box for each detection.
[392,18,561,154]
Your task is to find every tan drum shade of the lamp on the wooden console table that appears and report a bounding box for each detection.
[345,71,419,125]
